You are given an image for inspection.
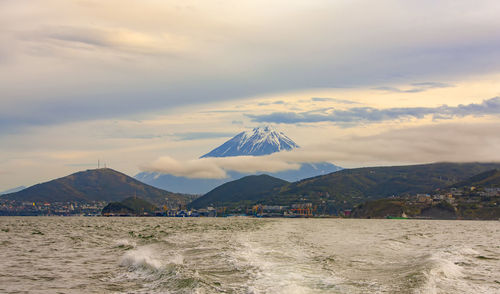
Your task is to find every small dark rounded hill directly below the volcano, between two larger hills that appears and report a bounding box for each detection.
[189,175,288,209]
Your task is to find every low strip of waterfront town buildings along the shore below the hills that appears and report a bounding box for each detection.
[0,187,500,220]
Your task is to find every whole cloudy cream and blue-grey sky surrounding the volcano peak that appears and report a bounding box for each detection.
[0,0,500,191]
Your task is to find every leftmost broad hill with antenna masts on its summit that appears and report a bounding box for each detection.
[0,168,188,206]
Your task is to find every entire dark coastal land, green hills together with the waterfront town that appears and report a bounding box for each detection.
[0,163,500,220]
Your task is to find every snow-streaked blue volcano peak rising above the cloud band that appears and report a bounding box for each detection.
[202,126,299,158]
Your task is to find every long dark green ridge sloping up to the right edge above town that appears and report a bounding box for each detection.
[272,163,500,208]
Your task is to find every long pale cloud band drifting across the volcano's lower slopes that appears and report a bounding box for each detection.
[141,123,500,179]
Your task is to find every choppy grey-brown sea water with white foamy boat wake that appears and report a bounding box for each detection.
[0,217,500,293]
